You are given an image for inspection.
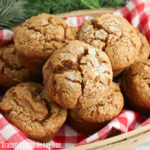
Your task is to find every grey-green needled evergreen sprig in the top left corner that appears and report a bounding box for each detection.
[0,0,27,29]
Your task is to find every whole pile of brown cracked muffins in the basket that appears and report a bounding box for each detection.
[0,14,150,142]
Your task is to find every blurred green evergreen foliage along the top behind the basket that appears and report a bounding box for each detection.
[0,0,128,29]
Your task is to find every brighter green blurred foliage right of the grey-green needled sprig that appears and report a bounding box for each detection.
[25,0,128,16]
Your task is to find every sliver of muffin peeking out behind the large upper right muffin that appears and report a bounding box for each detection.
[136,30,150,62]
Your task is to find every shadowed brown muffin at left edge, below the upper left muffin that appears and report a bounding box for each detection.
[0,44,33,87]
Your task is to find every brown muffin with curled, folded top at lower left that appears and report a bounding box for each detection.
[0,82,67,142]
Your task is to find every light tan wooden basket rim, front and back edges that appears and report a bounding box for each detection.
[57,8,150,150]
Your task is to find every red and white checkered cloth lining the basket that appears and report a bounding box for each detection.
[0,0,150,150]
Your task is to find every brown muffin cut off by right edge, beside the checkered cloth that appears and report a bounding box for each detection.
[122,60,150,114]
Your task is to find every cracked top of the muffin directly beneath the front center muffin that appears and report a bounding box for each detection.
[69,82,124,123]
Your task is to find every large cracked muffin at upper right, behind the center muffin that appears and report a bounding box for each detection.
[78,14,141,77]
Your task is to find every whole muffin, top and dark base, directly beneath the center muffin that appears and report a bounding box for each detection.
[68,82,124,134]
